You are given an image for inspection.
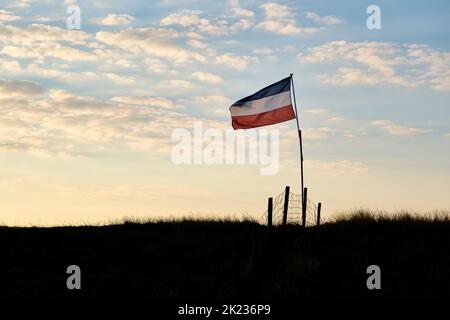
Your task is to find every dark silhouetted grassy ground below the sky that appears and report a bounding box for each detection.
[0,210,450,301]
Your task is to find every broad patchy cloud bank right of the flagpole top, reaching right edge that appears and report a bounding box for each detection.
[297,40,450,90]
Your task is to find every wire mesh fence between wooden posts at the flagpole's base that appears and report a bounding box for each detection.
[260,190,318,227]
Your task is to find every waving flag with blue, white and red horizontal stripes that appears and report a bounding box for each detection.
[230,77,295,130]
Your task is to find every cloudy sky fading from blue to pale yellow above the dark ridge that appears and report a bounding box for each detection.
[0,0,450,225]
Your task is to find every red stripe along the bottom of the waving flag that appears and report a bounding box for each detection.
[231,104,295,129]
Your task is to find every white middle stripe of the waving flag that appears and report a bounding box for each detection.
[230,91,291,117]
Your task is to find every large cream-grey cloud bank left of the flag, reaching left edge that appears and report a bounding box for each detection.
[0,80,206,157]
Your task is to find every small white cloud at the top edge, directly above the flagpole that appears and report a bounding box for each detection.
[256,2,319,35]
